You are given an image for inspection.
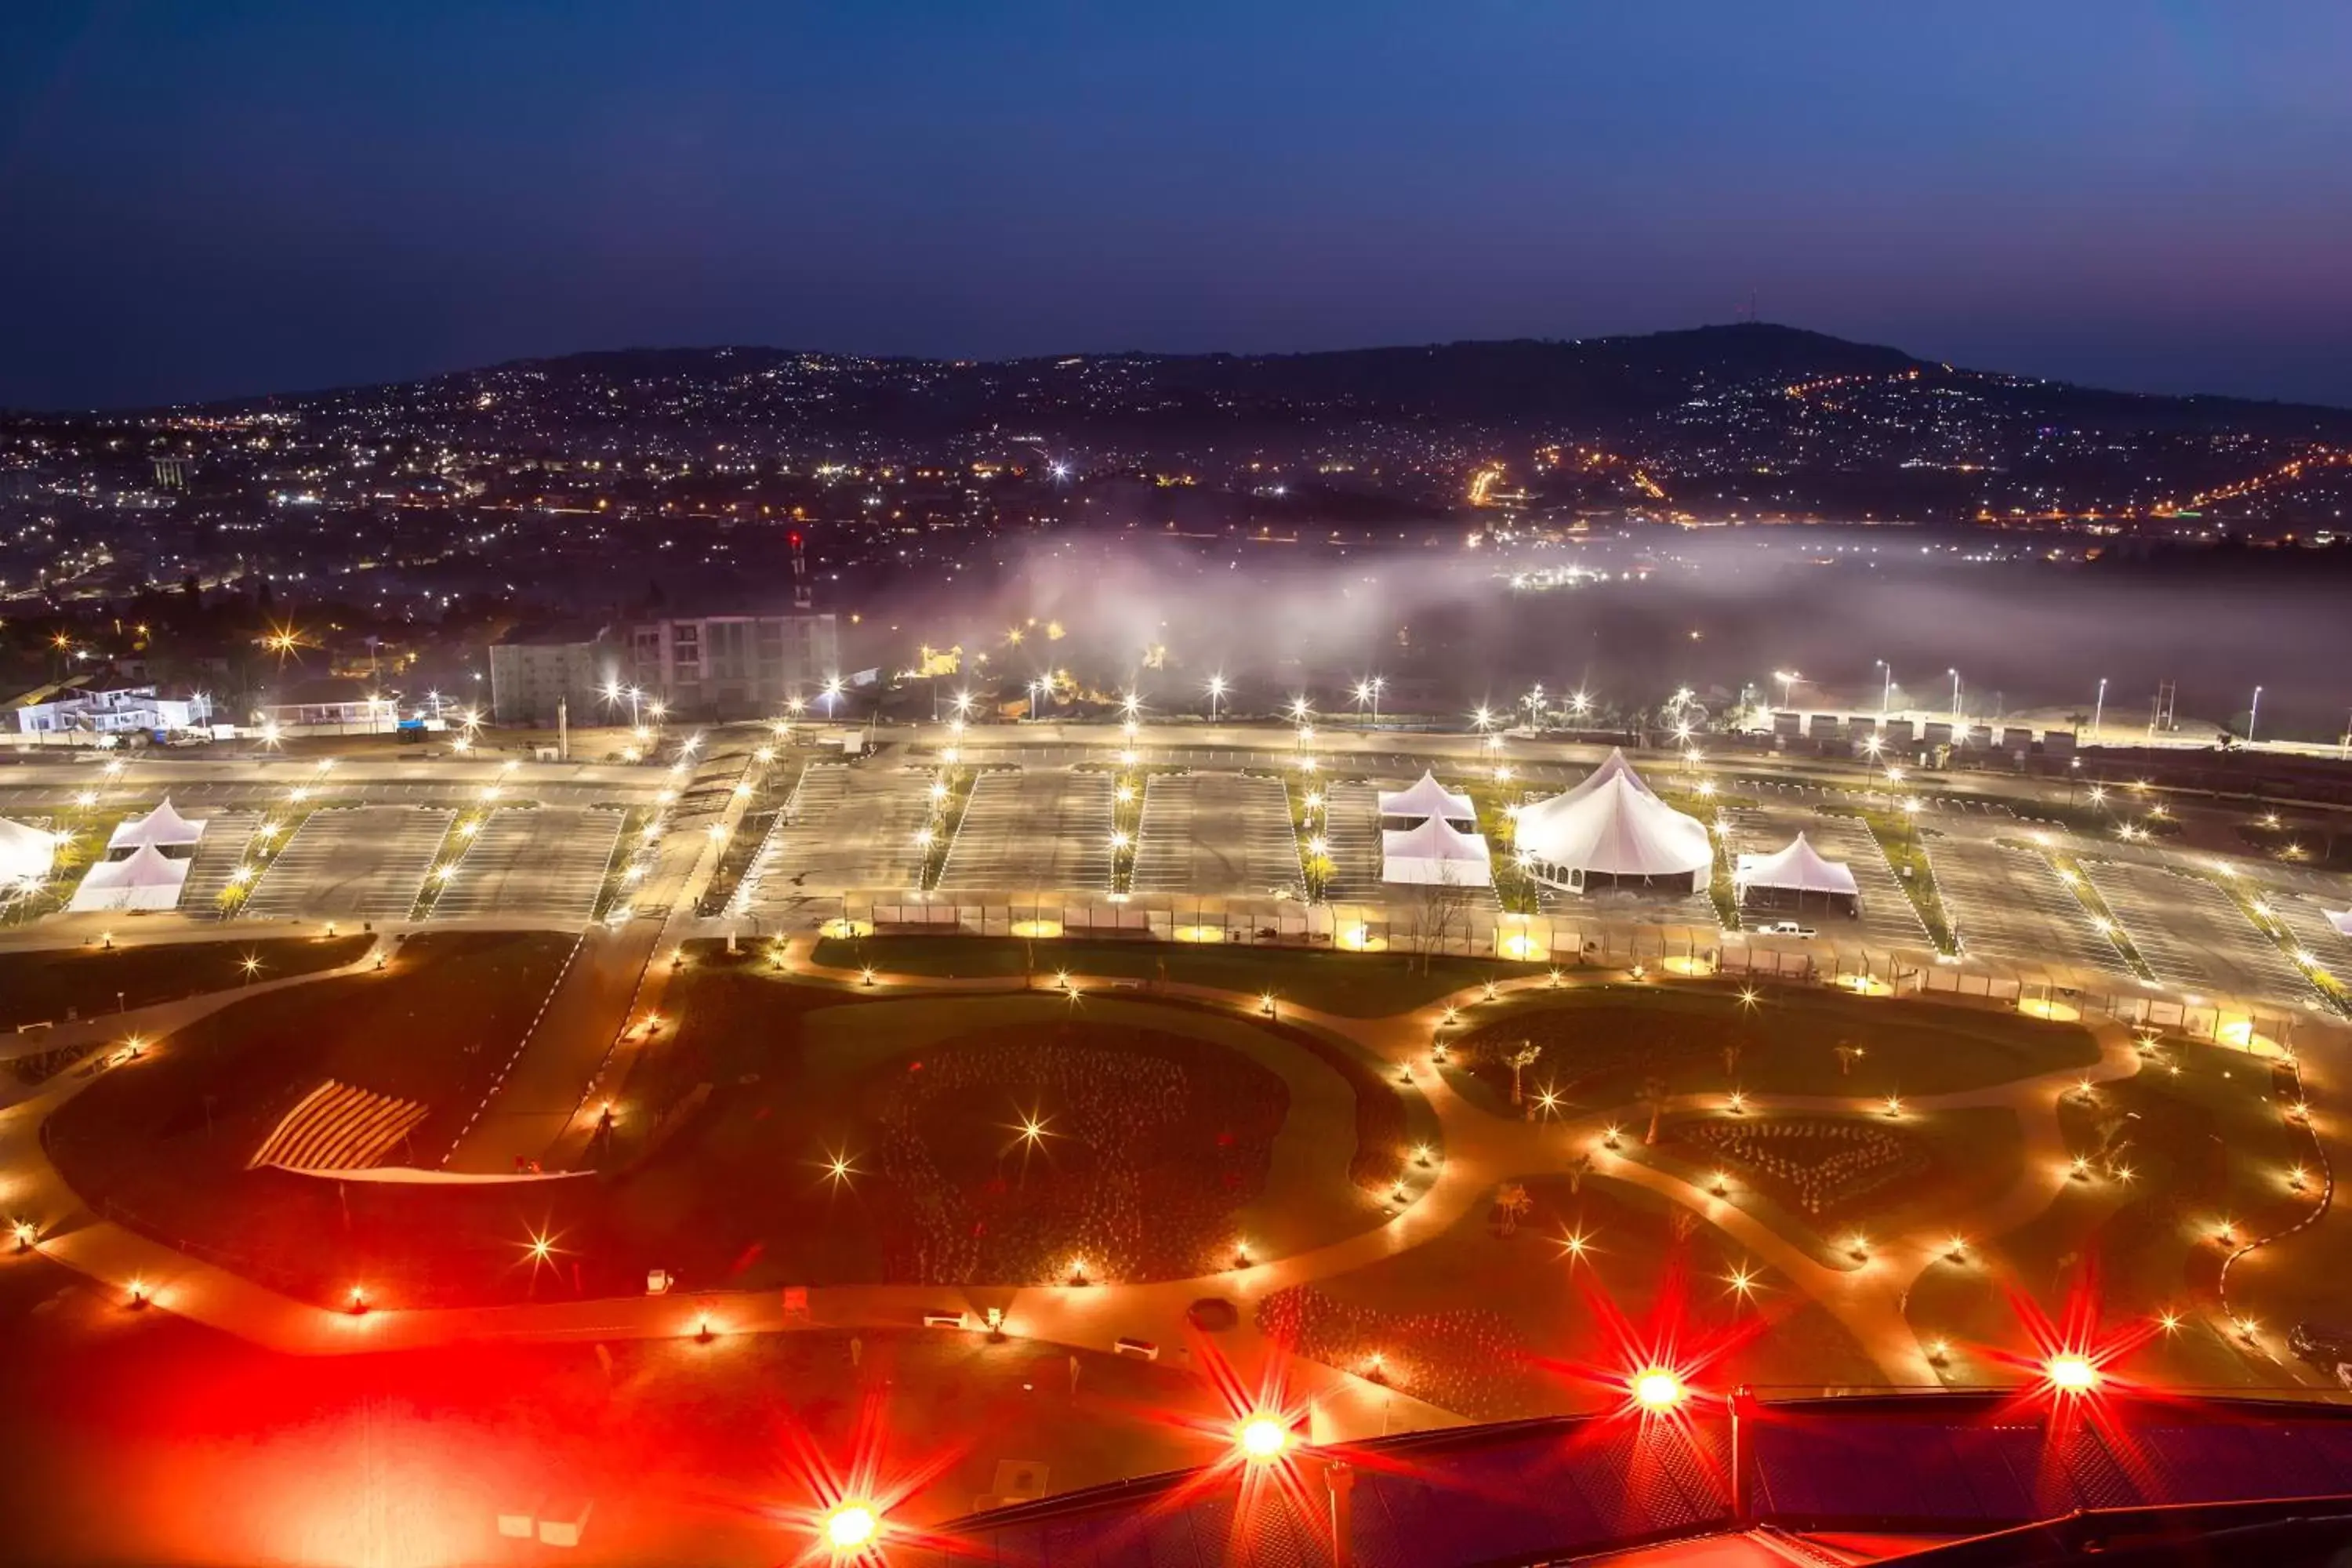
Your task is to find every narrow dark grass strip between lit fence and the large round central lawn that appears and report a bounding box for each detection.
[816,935,1524,1018]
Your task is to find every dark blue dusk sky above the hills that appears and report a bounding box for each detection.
[0,0,2352,407]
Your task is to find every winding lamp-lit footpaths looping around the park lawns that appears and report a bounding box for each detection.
[0,935,2296,1439]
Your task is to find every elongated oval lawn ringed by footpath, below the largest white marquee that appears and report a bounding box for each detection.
[1449,982,2098,1114]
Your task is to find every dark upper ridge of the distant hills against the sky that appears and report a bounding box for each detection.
[214,322,2352,440]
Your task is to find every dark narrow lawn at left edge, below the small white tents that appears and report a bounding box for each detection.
[0,935,376,1029]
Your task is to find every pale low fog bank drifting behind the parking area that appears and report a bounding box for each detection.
[868,529,2352,741]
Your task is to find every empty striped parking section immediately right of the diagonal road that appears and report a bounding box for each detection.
[743,762,934,919]
